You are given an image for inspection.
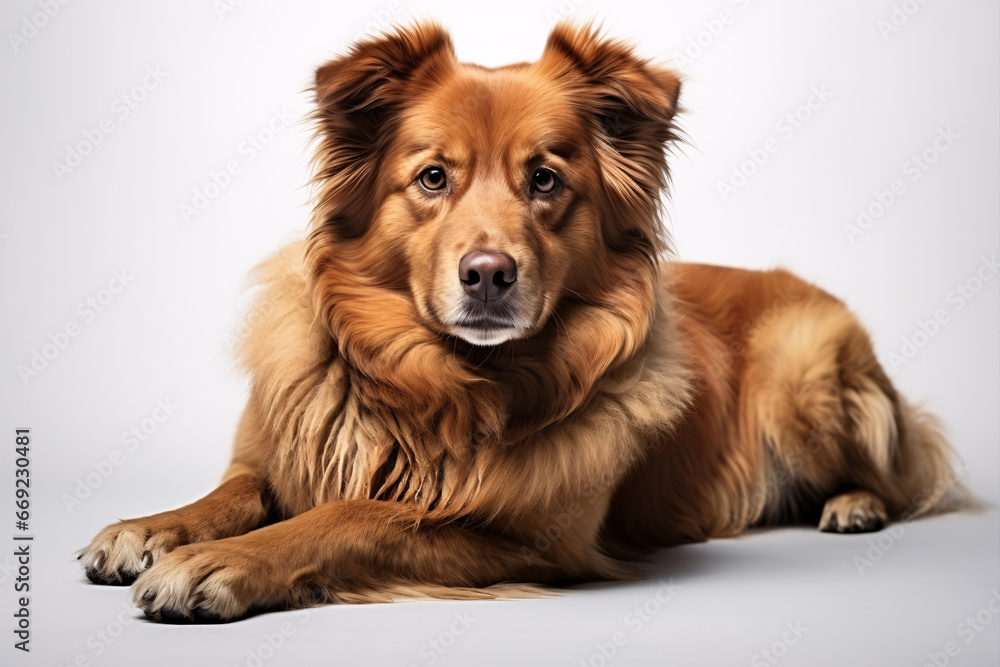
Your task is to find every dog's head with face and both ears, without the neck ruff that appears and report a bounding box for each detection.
[316,25,679,345]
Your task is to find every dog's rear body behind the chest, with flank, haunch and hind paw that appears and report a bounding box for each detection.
[607,262,955,549]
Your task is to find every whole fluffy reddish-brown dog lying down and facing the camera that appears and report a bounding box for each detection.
[80,23,954,622]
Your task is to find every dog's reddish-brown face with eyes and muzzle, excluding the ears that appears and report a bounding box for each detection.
[390,66,600,345]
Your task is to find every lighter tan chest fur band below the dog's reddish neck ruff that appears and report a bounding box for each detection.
[243,244,689,536]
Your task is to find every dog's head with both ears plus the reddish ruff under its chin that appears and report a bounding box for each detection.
[309,24,680,436]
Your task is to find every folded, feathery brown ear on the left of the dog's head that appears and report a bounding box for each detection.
[313,22,455,237]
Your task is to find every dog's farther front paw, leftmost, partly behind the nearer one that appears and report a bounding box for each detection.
[77,516,187,585]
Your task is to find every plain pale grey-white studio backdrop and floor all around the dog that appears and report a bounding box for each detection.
[0,0,1000,667]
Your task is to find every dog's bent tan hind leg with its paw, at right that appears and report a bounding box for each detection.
[741,291,954,533]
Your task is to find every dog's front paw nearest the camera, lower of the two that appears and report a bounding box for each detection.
[132,542,272,623]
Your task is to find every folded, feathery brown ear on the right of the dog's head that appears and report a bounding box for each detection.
[540,23,681,257]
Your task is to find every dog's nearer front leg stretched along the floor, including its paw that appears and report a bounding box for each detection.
[133,500,561,622]
